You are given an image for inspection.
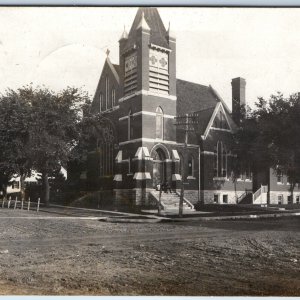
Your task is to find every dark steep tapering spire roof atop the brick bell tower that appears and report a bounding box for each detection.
[127,7,169,49]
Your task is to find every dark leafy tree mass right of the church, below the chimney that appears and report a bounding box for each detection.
[235,93,300,203]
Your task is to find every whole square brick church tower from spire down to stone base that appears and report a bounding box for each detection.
[118,7,177,207]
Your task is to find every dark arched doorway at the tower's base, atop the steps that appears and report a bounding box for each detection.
[151,148,166,188]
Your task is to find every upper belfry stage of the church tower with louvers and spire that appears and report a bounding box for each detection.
[119,8,176,97]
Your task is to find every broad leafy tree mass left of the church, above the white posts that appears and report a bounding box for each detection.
[0,86,88,205]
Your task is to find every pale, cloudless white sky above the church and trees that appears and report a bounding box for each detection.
[0,7,300,107]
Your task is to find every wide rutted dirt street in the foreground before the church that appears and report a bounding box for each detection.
[0,210,300,296]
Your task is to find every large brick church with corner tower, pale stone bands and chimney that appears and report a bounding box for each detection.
[78,7,298,206]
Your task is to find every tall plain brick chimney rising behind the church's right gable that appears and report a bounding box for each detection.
[231,77,246,125]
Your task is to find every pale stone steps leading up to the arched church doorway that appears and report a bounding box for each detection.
[150,191,195,213]
